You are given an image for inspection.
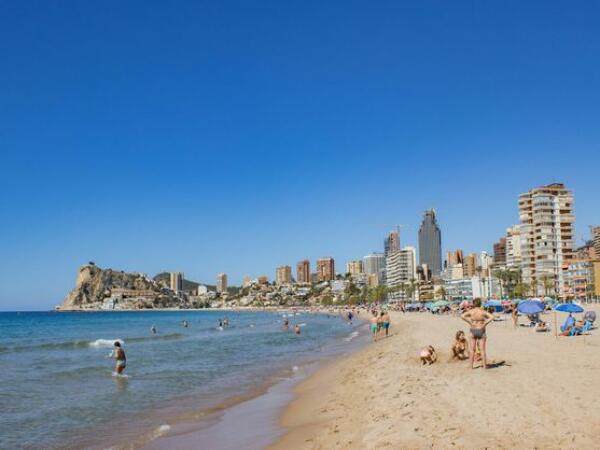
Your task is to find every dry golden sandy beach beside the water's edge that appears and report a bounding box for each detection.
[270,313,600,450]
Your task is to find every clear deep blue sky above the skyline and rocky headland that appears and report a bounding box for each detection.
[0,0,600,309]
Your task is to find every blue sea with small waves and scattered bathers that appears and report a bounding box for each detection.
[0,310,367,449]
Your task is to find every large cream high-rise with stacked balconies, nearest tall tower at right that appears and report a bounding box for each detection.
[519,183,575,297]
